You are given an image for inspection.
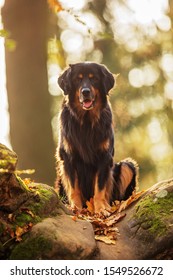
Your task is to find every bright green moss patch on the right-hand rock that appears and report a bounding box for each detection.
[135,193,173,236]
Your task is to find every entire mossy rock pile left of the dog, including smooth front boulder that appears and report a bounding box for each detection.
[0,145,96,259]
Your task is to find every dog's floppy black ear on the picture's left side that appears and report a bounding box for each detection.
[58,67,72,95]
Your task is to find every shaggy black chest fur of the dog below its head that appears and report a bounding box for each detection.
[61,106,113,164]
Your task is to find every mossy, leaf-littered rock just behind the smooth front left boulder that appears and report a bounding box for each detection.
[0,180,64,258]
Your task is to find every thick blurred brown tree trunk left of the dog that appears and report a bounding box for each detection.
[2,0,55,185]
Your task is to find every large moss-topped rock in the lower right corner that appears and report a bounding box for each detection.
[96,179,173,260]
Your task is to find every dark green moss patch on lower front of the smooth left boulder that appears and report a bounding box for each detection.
[9,236,52,260]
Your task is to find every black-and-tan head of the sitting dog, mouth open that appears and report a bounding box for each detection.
[58,62,114,110]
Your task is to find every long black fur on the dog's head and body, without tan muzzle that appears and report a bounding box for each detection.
[57,63,135,209]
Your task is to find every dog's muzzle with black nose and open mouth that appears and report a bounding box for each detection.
[79,87,94,110]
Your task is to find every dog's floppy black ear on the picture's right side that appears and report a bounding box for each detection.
[101,65,115,94]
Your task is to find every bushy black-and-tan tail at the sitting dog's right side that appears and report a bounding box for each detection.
[112,158,139,201]
